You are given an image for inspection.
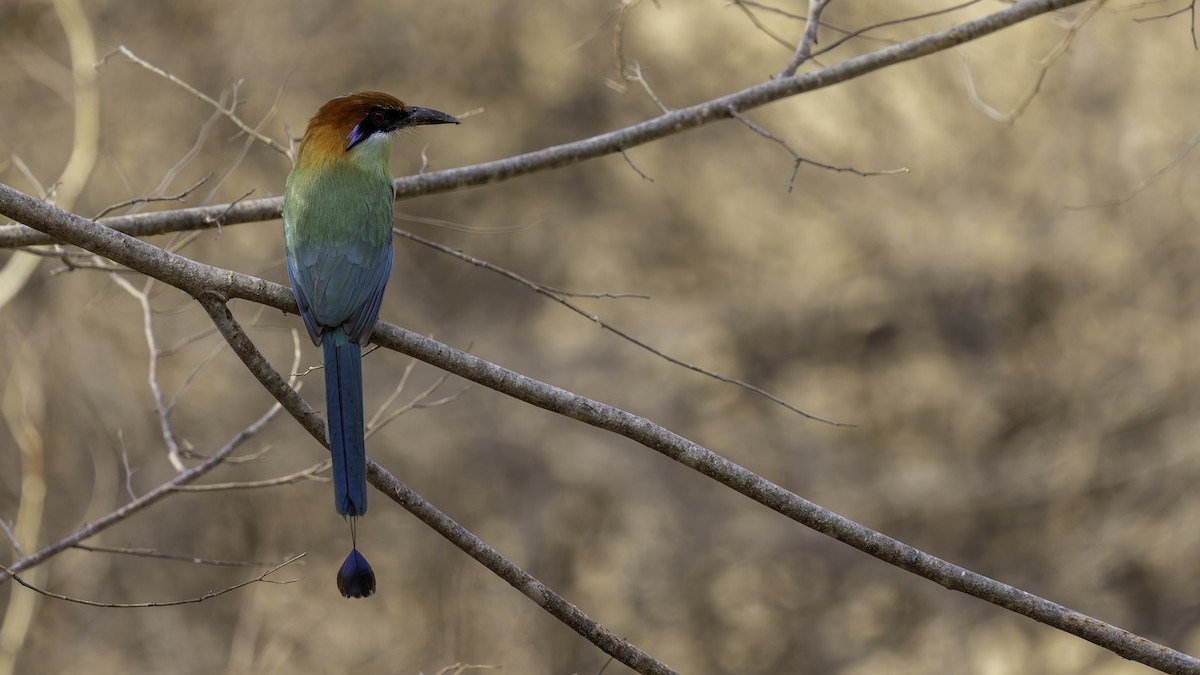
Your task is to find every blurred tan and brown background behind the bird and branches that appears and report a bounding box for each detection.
[0,0,1200,675]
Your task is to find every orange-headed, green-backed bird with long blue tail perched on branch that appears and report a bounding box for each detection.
[283,91,461,598]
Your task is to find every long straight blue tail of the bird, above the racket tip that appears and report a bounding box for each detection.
[322,328,367,516]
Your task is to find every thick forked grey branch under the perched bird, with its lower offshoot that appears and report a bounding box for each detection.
[0,159,1200,673]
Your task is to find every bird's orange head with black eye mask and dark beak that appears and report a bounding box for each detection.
[296,91,461,163]
